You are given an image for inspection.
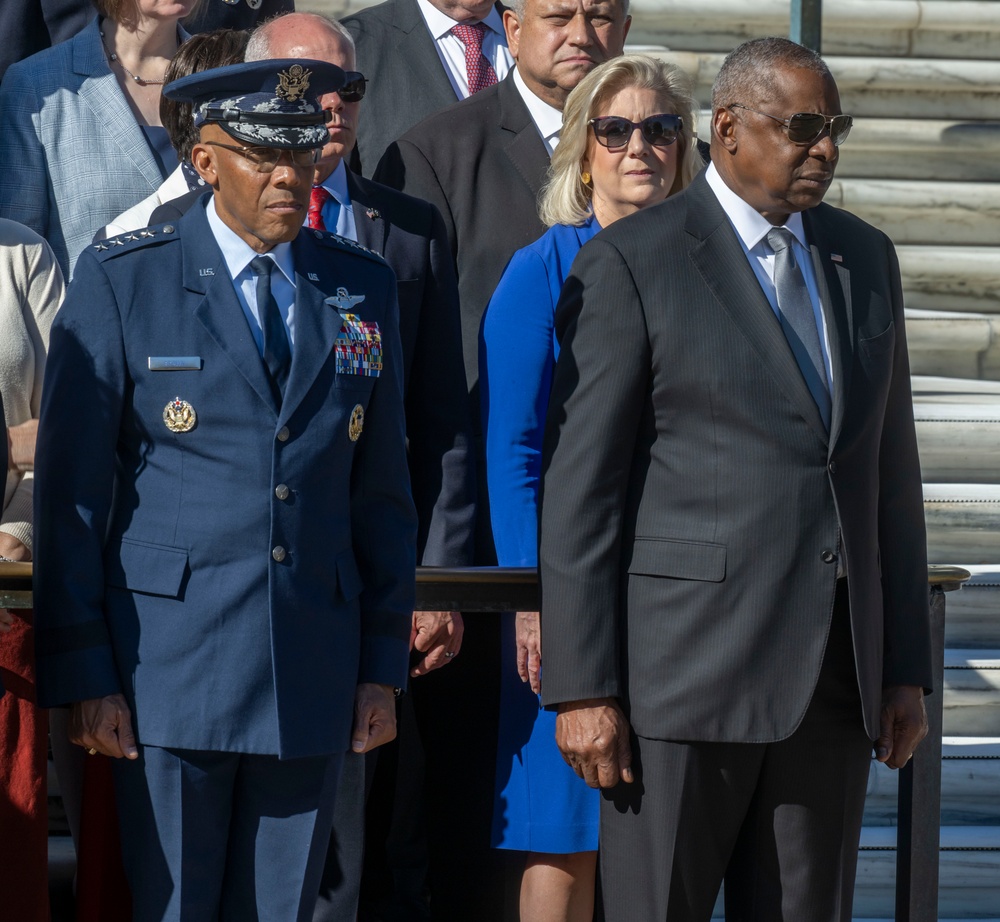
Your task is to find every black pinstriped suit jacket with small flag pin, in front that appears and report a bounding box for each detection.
[539,175,931,742]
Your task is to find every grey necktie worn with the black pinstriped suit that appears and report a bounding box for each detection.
[767,227,831,431]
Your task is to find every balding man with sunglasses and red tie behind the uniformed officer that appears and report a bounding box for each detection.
[247,13,475,922]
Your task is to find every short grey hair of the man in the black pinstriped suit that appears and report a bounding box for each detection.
[712,36,832,112]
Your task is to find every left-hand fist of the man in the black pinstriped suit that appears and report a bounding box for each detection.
[556,698,632,788]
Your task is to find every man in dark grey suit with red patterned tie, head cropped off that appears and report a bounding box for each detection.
[343,0,513,176]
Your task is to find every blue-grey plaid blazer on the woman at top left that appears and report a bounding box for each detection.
[0,19,170,278]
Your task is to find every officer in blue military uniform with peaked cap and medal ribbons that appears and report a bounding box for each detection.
[35,60,416,922]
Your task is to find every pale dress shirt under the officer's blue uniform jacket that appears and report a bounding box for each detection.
[205,195,295,356]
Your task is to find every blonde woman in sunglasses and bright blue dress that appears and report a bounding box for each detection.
[480,55,702,922]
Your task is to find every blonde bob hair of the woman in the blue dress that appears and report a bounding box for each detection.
[538,54,704,227]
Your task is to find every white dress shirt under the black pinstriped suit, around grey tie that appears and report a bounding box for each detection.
[705,163,836,398]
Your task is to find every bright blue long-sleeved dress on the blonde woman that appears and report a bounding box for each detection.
[479,216,601,854]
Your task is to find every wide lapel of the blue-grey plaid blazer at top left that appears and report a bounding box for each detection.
[73,19,163,189]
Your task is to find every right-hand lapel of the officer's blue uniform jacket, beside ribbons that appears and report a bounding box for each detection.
[278,234,340,423]
